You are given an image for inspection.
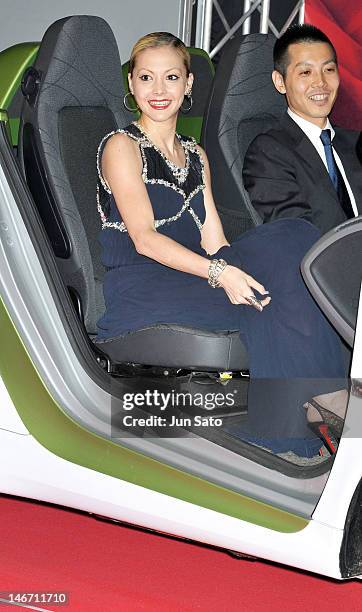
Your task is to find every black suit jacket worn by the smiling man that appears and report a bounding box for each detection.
[243,113,362,233]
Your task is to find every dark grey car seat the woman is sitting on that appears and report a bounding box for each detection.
[19,16,248,371]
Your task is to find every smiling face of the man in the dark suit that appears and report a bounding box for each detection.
[272,42,339,128]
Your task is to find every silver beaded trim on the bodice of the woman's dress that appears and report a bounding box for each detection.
[97,122,205,232]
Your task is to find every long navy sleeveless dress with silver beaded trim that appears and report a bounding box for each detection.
[97,123,345,456]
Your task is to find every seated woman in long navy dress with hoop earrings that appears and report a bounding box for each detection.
[98,32,347,457]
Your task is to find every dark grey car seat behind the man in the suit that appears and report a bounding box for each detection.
[201,34,286,241]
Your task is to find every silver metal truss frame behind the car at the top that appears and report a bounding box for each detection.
[192,0,305,58]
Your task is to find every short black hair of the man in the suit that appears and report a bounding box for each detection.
[273,23,337,77]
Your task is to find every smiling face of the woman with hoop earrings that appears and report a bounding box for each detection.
[128,46,193,121]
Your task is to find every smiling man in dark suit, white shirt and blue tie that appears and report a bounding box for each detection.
[243,24,362,233]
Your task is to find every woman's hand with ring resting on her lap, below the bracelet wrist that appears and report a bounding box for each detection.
[218,265,271,310]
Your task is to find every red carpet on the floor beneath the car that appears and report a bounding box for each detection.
[0,496,362,612]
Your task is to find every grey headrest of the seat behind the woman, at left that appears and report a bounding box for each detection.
[23,15,123,115]
